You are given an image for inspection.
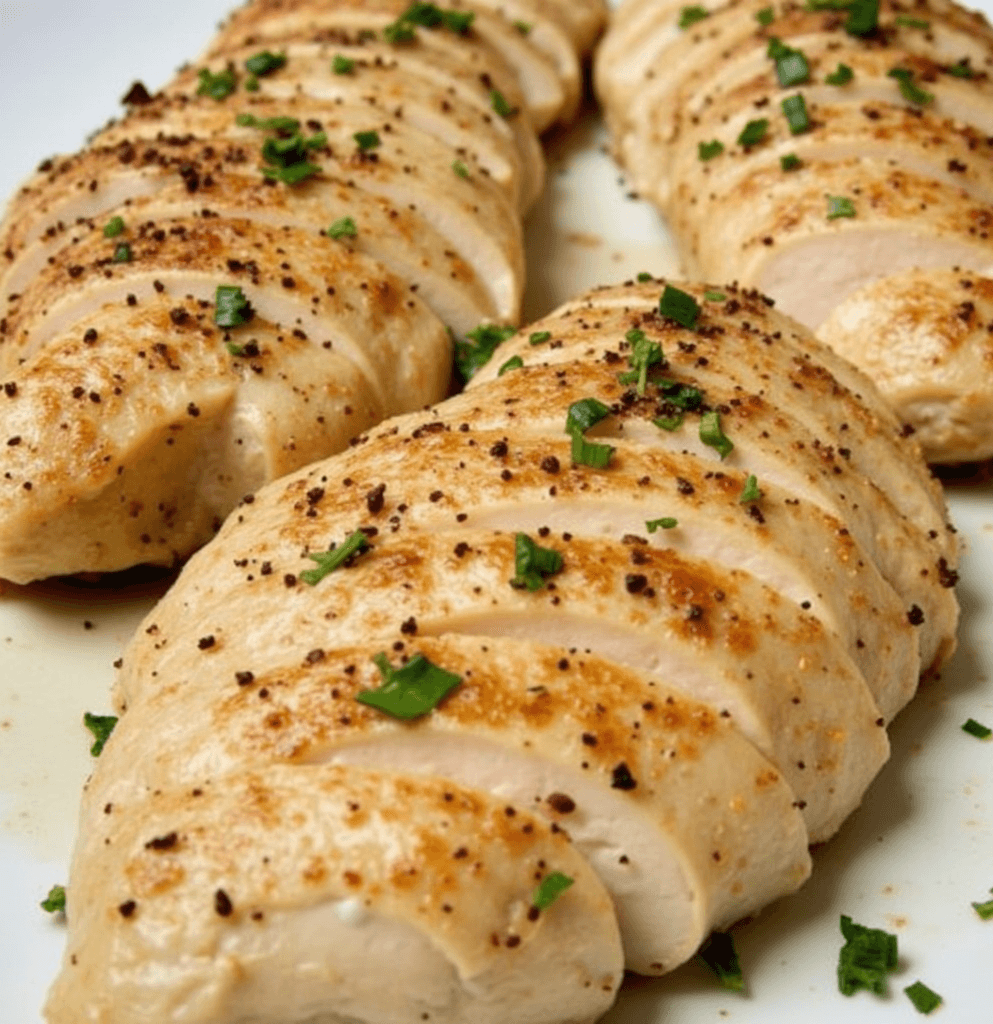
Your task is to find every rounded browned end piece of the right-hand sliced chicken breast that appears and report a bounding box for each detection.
[818,269,993,463]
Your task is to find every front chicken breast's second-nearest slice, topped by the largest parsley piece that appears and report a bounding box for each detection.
[89,630,810,974]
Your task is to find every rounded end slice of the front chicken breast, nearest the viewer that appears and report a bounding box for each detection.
[45,765,622,1024]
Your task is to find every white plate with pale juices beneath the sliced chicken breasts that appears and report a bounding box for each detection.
[0,0,993,1024]
